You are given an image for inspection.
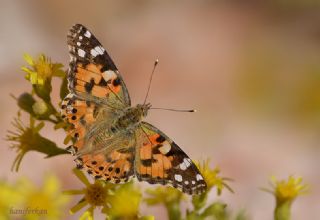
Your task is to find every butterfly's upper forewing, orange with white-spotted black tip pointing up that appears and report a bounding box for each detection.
[68,24,131,109]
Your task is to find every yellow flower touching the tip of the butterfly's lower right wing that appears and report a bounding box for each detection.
[195,160,233,195]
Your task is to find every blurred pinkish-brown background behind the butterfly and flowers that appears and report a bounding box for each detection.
[0,0,320,220]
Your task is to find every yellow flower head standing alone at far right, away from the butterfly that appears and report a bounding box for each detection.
[263,176,308,203]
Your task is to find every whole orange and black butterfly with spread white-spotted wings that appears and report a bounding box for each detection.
[61,24,207,195]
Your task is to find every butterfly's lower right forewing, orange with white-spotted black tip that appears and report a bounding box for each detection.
[135,122,207,194]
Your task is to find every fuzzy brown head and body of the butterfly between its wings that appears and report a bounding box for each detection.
[111,103,151,132]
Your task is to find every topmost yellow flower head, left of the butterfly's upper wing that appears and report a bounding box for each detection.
[21,54,65,85]
